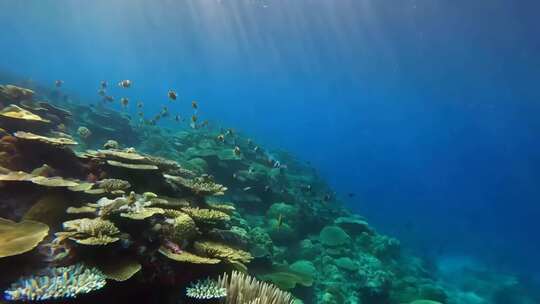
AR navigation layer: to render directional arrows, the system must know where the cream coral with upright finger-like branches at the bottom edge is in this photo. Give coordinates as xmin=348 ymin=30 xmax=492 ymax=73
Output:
xmin=218 ymin=271 xmax=293 ymax=304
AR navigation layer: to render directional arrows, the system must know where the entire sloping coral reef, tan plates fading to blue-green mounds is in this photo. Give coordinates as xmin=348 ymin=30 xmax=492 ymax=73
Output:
xmin=0 ymin=81 xmax=536 ymax=304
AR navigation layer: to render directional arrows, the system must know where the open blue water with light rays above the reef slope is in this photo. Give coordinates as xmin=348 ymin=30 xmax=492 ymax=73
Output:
xmin=0 ymin=0 xmax=540 ymax=286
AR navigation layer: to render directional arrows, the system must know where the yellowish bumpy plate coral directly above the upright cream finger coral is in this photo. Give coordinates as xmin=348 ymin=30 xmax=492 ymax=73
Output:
xmin=193 ymin=241 xmax=253 ymax=264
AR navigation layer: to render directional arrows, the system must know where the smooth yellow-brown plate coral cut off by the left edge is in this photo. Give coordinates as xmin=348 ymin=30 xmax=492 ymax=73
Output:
xmin=0 ymin=218 xmax=49 ymax=258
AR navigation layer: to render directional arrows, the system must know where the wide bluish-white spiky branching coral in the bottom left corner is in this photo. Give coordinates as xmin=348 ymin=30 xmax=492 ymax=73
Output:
xmin=4 ymin=264 xmax=107 ymax=301
